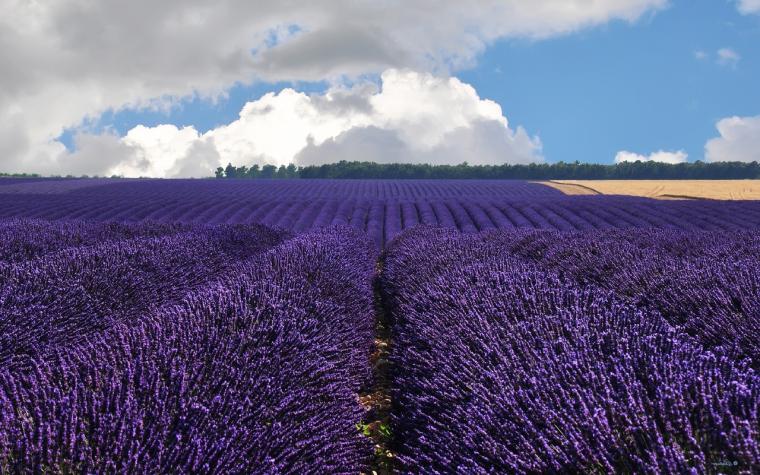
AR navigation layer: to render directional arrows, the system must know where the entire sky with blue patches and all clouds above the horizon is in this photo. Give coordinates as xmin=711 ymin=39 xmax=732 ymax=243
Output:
xmin=0 ymin=0 xmax=760 ymax=177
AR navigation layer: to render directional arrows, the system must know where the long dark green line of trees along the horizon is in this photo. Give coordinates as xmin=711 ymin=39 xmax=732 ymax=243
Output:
xmin=216 ymin=161 xmax=760 ymax=180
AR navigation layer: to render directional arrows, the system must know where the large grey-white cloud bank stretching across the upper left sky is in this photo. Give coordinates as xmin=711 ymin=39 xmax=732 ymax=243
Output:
xmin=0 ymin=0 xmax=668 ymax=173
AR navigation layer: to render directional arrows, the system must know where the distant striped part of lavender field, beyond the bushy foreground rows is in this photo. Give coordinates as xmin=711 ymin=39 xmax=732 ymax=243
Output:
xmin=0 ymin=178 xmax=760 ymax=247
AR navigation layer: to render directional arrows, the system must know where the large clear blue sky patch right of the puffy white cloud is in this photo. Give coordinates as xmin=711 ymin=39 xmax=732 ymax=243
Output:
xmin=459 ymin=0 xmax=760 ymax=163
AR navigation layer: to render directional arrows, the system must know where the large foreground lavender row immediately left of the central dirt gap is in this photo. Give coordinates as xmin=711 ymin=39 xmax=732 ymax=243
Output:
xmin=0 ymin=229 xmax=374 ymax=473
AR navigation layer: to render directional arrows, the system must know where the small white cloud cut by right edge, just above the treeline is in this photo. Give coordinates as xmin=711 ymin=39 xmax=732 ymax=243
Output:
xmin=705 ymin=116 xmax=760 ymax=162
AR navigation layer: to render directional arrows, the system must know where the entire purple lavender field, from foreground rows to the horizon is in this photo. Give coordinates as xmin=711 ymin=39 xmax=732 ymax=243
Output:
xmin=0 ymin=179 xmax=760 ymax=473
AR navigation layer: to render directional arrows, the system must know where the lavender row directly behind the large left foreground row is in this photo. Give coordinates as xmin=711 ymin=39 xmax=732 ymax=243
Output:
xmin=0 ymin=226 xmax=284 ymax=366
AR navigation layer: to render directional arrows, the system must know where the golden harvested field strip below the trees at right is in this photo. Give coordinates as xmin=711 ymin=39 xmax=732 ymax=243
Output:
xmin=541 ymin=180 xmax=760 ymax=200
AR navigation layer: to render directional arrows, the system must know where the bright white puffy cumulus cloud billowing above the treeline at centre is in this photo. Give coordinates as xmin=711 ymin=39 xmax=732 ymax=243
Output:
xmin=96 ymin=70 xmax=543 ymax=177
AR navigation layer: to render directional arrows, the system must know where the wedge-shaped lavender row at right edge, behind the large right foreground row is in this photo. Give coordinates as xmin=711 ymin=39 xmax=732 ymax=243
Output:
xmin=498 ymin=230 xmax=760 ymax=367
